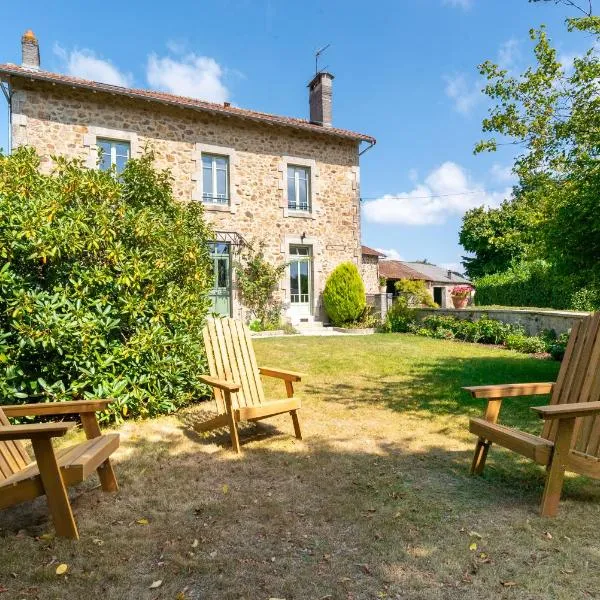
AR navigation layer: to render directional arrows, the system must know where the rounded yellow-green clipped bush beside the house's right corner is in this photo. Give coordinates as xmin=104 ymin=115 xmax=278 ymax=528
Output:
xmin=323 ymin=262 xmax=367 ymax=326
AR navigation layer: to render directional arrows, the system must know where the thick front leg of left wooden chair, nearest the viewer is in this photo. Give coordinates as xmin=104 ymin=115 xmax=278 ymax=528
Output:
xmin=32 ymin=438 xmax=79 ymax=540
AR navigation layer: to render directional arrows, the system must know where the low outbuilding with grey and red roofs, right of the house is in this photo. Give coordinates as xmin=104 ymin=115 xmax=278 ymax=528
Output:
xmin=379 ymin=260 xmax=472 ymax=308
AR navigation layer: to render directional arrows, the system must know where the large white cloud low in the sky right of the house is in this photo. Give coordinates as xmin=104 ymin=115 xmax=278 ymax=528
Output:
xmin=363 ymin=161 xmax=511 ymax=225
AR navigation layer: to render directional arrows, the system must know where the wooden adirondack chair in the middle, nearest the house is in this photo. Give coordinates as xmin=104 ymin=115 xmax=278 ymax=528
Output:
xmin=194 ymin=318 xmax=302 ymax=452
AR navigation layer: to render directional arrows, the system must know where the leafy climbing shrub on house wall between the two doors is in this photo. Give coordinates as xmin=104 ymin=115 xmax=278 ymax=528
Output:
xmin=235 ymin=243 xmax=286 ymax=331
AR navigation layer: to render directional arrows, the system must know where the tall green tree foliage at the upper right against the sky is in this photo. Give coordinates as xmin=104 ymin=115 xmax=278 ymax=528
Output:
xmin=460 ymin=8 xmax=600 ymax=310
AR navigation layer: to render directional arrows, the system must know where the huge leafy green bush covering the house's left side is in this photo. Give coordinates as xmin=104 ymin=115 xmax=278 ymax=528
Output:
xmin=0 ymin=149 xmax=210 ymax=420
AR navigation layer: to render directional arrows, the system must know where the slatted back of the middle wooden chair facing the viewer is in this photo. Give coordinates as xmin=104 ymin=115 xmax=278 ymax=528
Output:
xmin=203 ymin=318 xmax=265 ymax=413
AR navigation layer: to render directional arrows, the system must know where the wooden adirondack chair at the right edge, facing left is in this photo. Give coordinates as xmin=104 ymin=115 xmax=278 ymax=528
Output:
xmin=463 ymin=313 xmax=600 ymax=517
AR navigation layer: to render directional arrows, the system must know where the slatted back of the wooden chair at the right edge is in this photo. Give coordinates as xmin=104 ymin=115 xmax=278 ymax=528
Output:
xmin=542 ymin=313 xmax=600 ymax=458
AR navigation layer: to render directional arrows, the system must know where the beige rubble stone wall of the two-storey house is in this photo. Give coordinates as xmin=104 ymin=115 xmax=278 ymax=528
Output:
xmin=12 ymin=78 xmax=360 ymax=318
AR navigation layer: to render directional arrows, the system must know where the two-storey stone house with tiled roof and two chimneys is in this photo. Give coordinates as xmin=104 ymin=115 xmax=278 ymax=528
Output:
xmin=0 ymin=31 xmax=375 ymax=323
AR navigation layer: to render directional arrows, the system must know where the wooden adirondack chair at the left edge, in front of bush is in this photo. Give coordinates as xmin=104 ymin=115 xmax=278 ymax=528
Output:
xmin=0 ymin=400 xmax=119 ymax=539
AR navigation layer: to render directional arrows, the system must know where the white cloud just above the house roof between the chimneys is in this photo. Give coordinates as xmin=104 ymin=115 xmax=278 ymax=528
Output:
xmin=146 ymin=52 xmax=229 ymax=102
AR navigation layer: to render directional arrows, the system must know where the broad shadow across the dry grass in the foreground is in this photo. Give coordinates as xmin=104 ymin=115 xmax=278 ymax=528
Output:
xmin=0 ymin=425 xmax=599 ymax=600
